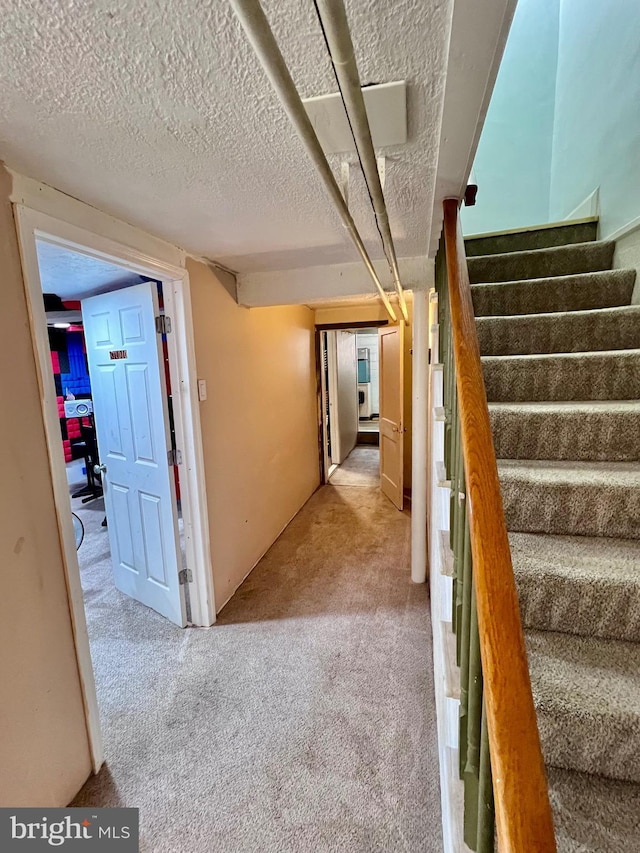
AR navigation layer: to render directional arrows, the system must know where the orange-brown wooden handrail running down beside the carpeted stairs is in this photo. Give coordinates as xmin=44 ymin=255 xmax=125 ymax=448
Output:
xmin=443 ymin=199 xmax=556 ymax=853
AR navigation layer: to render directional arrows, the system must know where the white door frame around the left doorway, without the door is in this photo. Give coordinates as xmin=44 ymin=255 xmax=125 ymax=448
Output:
xmin=14 ymin=204 xmax=216 ymax=773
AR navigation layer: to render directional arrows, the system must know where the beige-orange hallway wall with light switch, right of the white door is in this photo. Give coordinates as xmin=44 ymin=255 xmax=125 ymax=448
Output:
xmin=187 ymin=261 xmax=320 ymax=611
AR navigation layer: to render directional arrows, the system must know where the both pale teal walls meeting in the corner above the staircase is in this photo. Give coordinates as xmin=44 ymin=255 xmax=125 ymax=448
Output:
xmin=462 ymin=0 xmax=640 ymax=237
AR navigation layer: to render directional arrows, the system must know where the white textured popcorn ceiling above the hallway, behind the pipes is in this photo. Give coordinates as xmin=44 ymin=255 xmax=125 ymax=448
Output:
xmin=0 ymin=0 xmax=452 ymax=271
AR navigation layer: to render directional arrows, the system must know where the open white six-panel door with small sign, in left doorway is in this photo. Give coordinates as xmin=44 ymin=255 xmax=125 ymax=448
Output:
xmin=82 ymin=282 xmax=186 ymax=627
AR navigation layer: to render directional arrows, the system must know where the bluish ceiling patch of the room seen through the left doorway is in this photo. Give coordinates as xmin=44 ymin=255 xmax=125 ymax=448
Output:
xmin=36 ymin=240 xmax=141 ymax=299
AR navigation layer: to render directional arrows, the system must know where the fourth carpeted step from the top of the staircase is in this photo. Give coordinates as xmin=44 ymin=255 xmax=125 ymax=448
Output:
xmin=476 ymin=305 xmax=640 ymax=355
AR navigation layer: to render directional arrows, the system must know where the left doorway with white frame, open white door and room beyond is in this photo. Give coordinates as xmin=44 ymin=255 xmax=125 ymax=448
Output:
xmin=16 ymin=205 xmax=215 ymax=772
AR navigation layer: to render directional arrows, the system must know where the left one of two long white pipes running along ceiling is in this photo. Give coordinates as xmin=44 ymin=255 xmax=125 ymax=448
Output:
xmin=230 ymin=0 xmax=406 ymax=322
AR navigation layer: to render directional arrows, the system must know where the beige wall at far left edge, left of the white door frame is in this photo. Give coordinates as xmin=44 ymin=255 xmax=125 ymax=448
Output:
xmin=0 ymin=165 xmax=91 ymax=806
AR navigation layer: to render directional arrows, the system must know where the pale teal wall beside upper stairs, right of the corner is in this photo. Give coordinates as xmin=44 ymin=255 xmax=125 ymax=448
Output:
xmin=550 ymin=0 xmax=640 ymax=236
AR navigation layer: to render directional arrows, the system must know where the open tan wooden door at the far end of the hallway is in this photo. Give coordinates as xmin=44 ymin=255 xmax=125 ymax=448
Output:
xmin=378 ymin=324 xmax=404 ymax=509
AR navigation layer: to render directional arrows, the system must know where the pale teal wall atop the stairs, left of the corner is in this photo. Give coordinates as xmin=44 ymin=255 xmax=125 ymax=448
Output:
xmin=462 ymin=0 xmax=560 ymax=234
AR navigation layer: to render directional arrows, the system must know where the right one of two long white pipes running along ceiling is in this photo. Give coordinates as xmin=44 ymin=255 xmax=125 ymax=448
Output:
xmin=314 ymin=0 xmax=409 ymax=322
